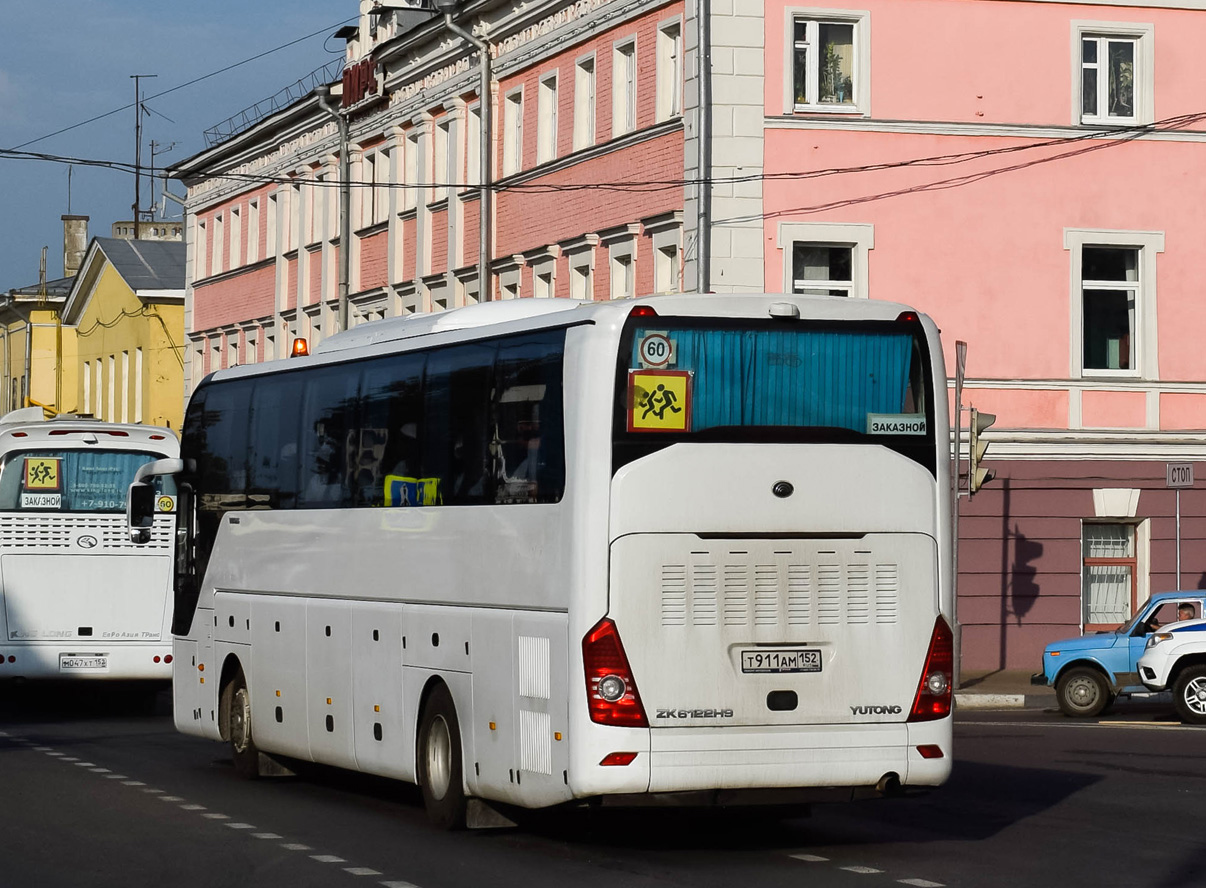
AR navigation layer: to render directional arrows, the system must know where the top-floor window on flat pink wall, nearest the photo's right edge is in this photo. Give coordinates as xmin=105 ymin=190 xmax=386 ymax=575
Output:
xmin=1072 ymin=22 xmax=1155 ymax=125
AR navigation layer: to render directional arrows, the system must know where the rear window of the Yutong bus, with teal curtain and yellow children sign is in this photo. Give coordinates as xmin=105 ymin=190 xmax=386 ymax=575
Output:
xmin=614 ymin=317 xmax=936 ymax=473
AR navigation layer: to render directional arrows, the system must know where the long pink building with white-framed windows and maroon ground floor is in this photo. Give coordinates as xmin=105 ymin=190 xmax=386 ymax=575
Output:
xmin=175 ymin=0 xmax=1206 ymax=671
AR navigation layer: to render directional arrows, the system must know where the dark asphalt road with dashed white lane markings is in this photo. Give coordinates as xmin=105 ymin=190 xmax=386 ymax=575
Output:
xmin=0 ymin=689 xmax=1206 ymax=888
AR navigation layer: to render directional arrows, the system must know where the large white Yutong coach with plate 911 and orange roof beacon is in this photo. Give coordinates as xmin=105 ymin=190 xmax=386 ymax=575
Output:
xmin=131 ymin=296 xmax=952 ymax=825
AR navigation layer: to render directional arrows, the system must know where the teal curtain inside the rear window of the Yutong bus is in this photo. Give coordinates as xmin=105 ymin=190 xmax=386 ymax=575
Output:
xmin=633 ymin=328 xmax=913 ymax=433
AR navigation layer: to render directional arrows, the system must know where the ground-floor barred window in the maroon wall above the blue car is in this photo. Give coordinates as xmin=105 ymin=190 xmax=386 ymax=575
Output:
xmin=1081 ymin=524 xmax=1138 ymax=630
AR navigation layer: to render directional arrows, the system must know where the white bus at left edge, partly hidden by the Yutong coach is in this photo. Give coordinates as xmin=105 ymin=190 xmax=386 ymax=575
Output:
xmin=0 ymin=407 xmax=180 ymax=683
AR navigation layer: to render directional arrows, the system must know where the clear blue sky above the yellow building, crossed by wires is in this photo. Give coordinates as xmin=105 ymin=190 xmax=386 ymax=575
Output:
xmin=0 ymin=0 xmax=359 ymax=291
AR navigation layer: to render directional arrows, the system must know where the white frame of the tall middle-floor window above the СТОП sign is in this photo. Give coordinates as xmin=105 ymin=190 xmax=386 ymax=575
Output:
xmin=1064 ymin=228 xmax=1164 ymax=380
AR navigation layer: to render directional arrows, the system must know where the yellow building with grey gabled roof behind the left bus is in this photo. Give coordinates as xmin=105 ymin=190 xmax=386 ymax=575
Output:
xmin=63 ymin=238 xmax=185 ymax=431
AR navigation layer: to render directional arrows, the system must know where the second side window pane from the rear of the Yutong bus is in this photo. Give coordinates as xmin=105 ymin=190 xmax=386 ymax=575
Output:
xmin=422 ymin=345 xmax=496 ymax=506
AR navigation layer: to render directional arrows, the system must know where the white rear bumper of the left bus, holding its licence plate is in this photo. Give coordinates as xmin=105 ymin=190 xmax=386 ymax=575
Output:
xmin=0 ymin=639 xmax=171 ymax=682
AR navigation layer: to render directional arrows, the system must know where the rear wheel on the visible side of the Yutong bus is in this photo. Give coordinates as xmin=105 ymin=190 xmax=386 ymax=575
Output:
xmin=417 ymin=683 xmax=467 ymax=830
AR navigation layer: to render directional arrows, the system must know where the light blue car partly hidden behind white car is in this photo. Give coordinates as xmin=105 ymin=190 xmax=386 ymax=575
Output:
xmin=1030 ymin=589 xmax=1206 ymax=718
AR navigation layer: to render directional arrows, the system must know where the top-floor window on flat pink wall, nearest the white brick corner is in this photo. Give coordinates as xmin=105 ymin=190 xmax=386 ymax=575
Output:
xmin=786 ymin=10 xmax=871 ymax=113
